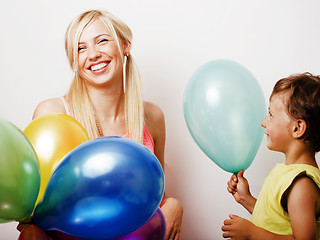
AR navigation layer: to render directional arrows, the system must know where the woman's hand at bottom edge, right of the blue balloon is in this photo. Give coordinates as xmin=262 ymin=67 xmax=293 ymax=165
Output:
xmin=161 ymin=198 xmax=183 ymax=240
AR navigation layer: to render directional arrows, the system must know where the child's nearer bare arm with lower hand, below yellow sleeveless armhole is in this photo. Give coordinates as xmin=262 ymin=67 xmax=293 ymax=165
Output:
xmin=221 ymin=174 xmax=320 ymax=240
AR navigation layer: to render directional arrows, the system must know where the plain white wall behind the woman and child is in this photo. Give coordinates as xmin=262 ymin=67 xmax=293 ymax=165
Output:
xmin=0 ymin=0 xmax=320 ymax=240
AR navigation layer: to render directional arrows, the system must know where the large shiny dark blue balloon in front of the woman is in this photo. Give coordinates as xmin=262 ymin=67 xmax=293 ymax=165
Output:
xmin=33 ymin=137 xmax=164 ymax=240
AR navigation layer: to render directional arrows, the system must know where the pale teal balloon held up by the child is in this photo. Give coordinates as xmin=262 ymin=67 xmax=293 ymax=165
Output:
xmin=183 ymin=60 xmax=266 ymax=173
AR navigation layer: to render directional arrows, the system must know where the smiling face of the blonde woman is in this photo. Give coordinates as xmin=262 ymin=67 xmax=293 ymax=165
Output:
xmin=78 ymin=20 xmax=123 ymax=85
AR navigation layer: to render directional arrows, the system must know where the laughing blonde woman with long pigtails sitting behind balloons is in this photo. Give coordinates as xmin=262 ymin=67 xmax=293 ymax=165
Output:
xmin=33 ymin=10 xmax=183 ymax=240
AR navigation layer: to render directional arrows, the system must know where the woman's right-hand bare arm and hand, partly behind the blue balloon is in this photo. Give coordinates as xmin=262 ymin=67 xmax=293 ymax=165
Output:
xmin=145 ymin=102 xmax=183 ymax=240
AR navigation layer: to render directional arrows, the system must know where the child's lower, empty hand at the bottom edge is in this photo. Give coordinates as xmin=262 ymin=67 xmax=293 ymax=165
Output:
xmin=221 ymin=214 xmax=254 ymax=240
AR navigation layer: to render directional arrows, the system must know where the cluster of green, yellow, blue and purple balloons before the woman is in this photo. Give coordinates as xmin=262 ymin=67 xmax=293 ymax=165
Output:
xmin=0 ymin=114 xmax=166 ymax=240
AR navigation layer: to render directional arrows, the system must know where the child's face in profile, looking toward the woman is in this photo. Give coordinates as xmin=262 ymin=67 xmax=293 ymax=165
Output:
xmin=261 ymin=93 xmax=294 ymax=153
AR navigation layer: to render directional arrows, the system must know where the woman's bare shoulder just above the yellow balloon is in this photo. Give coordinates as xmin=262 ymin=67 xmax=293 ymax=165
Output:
xmin=33 ymin=98 xmax=66 ymax=119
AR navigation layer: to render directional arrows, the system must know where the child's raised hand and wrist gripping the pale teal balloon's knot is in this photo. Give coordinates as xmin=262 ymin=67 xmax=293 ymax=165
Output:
xmin=227 ymin=170 xmax=257 ymax=213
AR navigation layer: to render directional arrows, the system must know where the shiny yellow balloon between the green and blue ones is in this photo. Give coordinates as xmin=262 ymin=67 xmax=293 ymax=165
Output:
xmin=24 ymin=113 xmax=89 ymax=204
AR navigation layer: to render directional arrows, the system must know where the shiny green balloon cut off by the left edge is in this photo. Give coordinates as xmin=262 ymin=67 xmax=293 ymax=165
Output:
xmin=0 ymin=118 xmax=40 ymax=222
